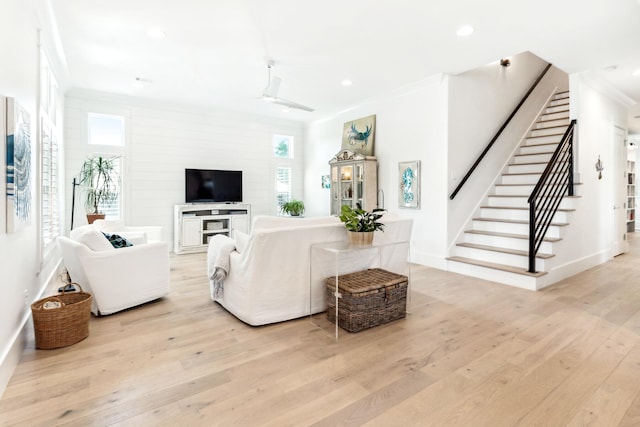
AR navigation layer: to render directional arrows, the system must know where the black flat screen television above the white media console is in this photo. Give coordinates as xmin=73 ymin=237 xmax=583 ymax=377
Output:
xmin=184 ymin=169 xmax=242 ymax=203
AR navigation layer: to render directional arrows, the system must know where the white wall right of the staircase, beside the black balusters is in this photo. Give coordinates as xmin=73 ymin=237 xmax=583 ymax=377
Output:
xmin=550 ymin=74 xmax=627 ymax=280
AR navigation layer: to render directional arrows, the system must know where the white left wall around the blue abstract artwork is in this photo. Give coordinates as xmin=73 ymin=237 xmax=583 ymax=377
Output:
xmin=0 ymin=0 xmax=64 ymax=394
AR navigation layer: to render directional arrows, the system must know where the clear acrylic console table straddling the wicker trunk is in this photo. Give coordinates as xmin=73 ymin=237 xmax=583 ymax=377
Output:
xmin=309 ymin=241 xmax=411 ymax=340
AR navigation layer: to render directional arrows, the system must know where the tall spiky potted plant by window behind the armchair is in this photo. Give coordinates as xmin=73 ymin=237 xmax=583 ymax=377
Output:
xmin=79 ymin=156 xmax=120 ymax=224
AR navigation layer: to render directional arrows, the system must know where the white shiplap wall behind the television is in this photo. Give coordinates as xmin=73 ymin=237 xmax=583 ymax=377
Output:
xmin=65 ymin=90 xmax=305 ymax=242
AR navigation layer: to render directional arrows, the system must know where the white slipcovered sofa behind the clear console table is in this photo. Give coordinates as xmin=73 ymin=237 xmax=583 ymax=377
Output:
xmin=208 ymin=214 xmax=413 ymax=326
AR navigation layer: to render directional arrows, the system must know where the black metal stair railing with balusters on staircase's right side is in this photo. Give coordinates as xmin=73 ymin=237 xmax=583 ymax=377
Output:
xmin=528 ymin=119 xmax=576 ymax=273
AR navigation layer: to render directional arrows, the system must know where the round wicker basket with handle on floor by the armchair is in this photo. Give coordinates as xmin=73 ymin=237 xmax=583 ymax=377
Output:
xmin=31 ymin=283 xmax=93 ymax=350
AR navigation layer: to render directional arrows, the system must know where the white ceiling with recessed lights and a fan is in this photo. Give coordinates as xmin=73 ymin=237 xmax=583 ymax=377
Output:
xmin=51 ymin=0 xmax=640 ymax=132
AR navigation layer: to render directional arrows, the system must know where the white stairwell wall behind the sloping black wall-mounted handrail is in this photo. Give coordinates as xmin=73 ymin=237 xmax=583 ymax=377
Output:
xmin=448 ymin=52 xmax=569 ymax=245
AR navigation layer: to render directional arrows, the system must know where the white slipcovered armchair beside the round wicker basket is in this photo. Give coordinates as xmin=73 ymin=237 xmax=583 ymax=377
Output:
xmin=57 ymin=226 xmax=170 ymax=315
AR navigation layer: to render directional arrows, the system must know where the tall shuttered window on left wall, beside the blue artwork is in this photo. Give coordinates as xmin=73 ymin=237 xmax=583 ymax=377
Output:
xmin=39 ymin=52 xmax=61 ymax=258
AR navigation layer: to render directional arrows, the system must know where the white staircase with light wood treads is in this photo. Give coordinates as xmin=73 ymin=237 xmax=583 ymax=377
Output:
xmin=447 ymin=92 xmax=574 ymax=290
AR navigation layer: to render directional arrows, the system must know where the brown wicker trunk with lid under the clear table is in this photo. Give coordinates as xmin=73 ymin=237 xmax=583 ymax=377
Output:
xmin=325 ymin=268 xmax=409 ymax=332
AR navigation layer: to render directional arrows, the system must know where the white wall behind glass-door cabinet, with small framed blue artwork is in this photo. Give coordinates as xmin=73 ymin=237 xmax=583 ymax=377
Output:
xmin=305 ymin=75 xmax=448 ymax=266
